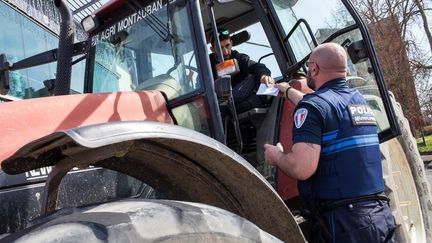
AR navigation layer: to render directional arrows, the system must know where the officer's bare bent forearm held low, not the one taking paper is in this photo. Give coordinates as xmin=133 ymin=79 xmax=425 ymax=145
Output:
xmin=264 ymin=142 xmax=321 ymax=180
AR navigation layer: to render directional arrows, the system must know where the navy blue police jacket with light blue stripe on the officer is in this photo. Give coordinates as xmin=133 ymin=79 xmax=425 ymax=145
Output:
xmin=293 ymin=79 xmax=384 ymax=200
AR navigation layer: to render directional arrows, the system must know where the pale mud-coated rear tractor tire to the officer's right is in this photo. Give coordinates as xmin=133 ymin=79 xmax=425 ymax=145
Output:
xmin=381 ymin=92 xmax=432 ymax=243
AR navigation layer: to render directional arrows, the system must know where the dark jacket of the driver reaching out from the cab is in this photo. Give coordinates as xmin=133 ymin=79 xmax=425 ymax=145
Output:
xmin=210 ymin=50 xmax=271 ymax=87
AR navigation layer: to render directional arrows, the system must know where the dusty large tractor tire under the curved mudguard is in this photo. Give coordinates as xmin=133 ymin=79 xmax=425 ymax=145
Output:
xmin=3 ymin=200 xmax=281 ymax=243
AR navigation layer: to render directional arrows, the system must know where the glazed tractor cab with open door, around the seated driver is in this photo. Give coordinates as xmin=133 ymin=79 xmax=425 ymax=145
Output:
xmin=82 ymin=0 xmax=398 ymax=191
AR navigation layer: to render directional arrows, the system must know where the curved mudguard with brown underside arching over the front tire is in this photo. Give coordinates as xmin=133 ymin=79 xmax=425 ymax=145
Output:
xmin=2 ymin=122 xmax=304 ymax=242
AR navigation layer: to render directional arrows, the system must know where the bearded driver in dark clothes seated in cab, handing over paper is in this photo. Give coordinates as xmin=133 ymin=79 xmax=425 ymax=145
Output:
xmin=210 ymin=29 xmax=275 ymax=117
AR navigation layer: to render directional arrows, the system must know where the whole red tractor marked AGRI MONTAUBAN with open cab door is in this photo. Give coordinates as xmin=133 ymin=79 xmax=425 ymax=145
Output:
xmin=0 ymin=0 xmax=432 ymax=242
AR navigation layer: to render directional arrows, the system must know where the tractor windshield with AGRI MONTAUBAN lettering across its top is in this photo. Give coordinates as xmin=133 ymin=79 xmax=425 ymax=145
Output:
xmin=89 ymin=0 xmax=200 ymax=99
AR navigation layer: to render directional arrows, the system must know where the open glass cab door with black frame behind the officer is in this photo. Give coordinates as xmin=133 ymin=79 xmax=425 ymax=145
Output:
xmin=257 ymin=0 xmax=400 ymax=143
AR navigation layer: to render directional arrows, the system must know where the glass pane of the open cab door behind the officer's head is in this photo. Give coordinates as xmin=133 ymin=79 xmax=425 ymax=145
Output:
xmin=271 ymin=0 xmax=390 ymax=137
